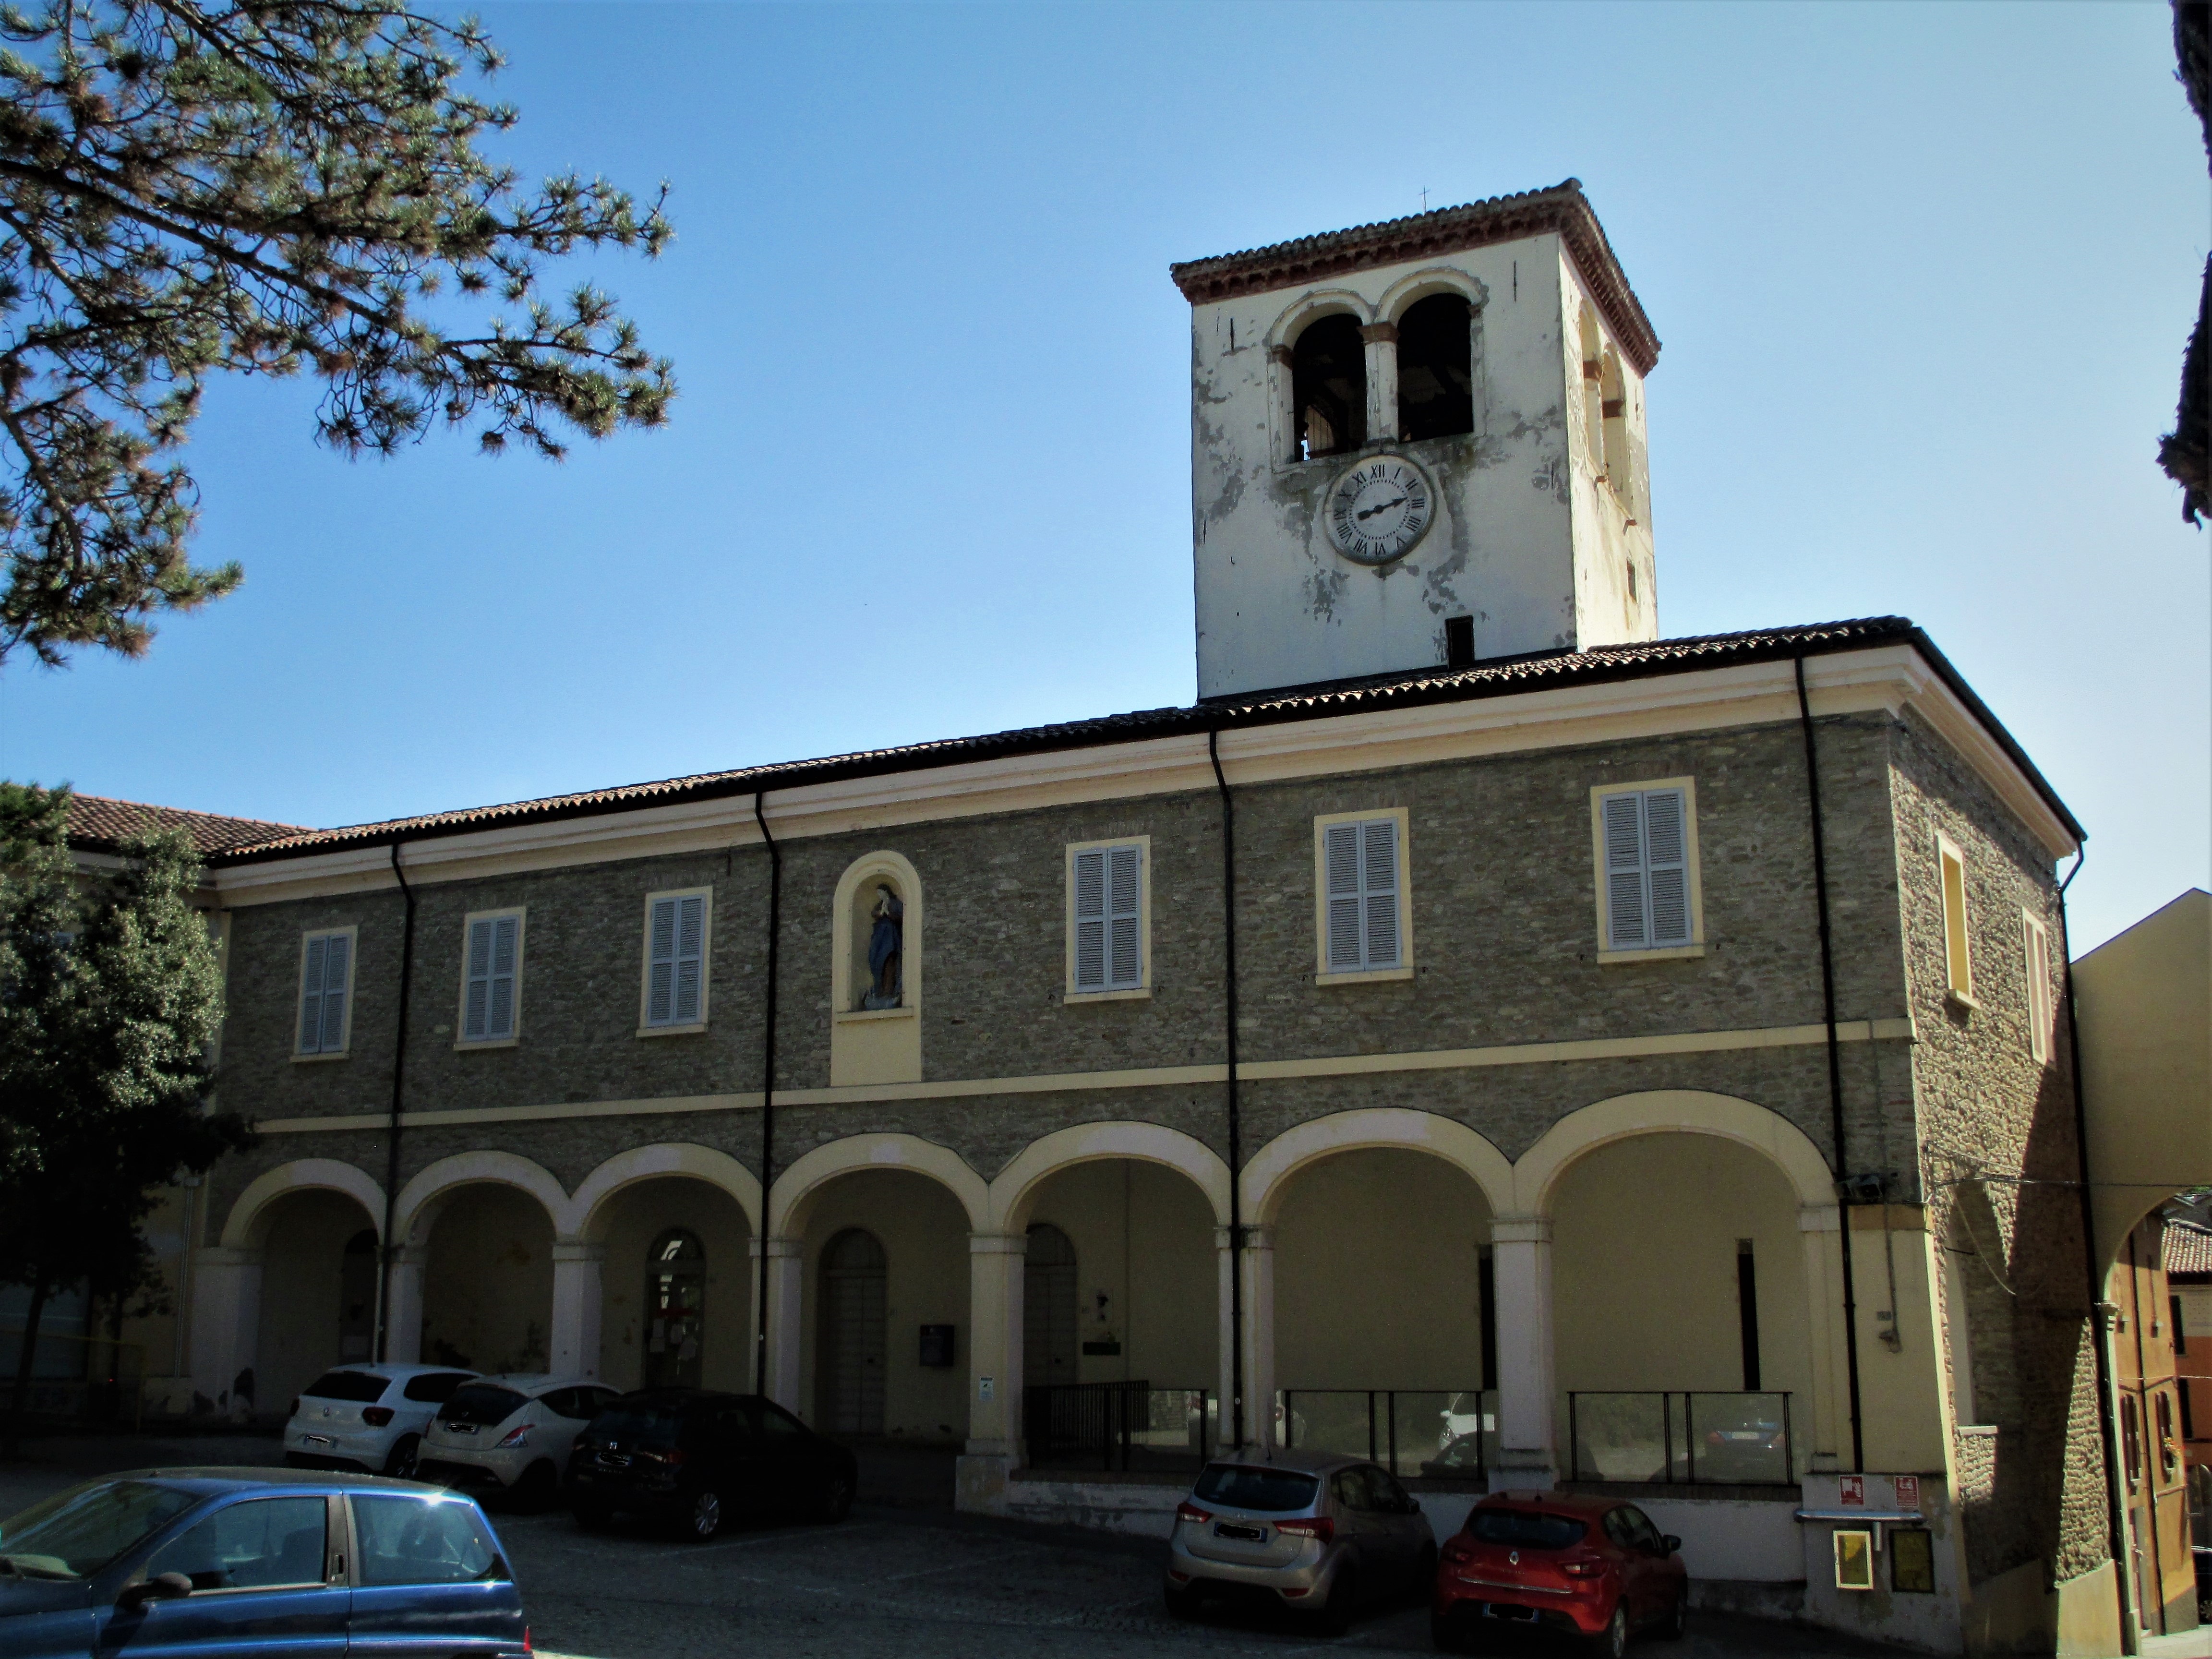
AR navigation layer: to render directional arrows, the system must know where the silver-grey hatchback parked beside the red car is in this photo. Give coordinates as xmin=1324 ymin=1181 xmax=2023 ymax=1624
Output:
xmin=1164 ymin=1451 xmax=1436 ymax=1630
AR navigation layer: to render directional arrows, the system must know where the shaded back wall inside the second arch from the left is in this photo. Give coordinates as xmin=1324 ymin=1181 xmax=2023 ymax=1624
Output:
xmin=422 ymin=1183 xmax=553 ymax=1371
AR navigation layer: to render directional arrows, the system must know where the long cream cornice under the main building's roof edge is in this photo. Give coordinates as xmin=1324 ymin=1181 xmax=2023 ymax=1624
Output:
xmin=215 ymin=644 xmax=2075 ymax=905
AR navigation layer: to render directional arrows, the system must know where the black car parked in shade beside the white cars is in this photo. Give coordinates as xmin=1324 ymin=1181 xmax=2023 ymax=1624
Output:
xmin=562 ymin=1389 xmax=858 ymax=1538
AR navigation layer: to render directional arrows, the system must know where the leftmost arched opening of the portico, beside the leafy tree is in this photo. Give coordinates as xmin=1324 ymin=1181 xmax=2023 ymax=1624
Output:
xmin=254 ymin=1188 xmax=376 ymax=1411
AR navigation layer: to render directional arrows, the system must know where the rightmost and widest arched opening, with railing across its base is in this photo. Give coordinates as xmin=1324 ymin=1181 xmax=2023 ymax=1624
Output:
xmin=1551 ymin=1130 xmax=1814 ymax=1482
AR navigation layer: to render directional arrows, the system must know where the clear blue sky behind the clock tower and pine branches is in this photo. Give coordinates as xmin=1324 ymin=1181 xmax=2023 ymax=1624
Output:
xmin=0 ymin=0 xmax=2212 ymax=949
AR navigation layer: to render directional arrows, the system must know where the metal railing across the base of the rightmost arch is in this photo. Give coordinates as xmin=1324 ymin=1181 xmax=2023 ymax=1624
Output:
xmin=1566 ymin=1389 xmax=1796 ymax=1484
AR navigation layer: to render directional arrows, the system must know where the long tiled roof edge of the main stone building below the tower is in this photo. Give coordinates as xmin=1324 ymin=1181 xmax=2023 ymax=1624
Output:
xmin=199 ymin=617 xmax=2084 ymax=865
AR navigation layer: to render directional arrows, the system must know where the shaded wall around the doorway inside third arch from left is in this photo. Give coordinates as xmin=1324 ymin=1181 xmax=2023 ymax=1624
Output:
xmin=600 ymin=1177 xmax=754 ymax=1394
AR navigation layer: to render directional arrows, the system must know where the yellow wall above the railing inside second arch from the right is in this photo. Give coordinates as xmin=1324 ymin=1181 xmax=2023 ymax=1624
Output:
xmin=1274 ymin=1148 xmax=1491 ymax=1389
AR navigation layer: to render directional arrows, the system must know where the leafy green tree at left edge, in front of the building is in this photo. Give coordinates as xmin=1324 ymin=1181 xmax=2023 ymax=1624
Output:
xmin=0 ymin=783 xmax=252 ymax=1447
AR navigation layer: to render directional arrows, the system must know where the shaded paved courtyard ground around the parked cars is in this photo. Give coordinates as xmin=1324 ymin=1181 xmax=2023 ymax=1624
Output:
xmin=0 ymin=1436 xmax=1902 ymax=1659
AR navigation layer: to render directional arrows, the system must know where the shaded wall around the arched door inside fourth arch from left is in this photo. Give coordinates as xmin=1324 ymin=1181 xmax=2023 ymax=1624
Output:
xmin=798 ymin=1170 xmax=974 ymax=1442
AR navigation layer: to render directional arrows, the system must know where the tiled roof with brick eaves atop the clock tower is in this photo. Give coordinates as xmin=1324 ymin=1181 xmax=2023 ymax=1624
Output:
xmin=1168 ymin=179 xmax=1659 ymax=374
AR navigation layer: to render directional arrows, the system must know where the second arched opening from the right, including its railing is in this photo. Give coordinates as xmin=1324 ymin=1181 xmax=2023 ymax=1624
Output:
xmin=1274 ymin=1146 xmax=1495 ymax=1476
